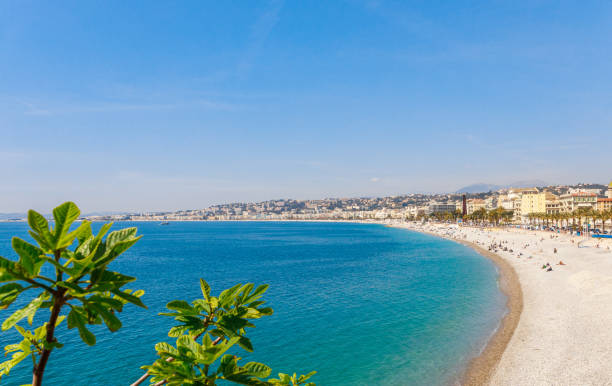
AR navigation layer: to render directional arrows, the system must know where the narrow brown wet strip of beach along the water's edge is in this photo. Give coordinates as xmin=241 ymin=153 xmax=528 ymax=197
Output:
xmin=390 ymin=223 xmax=523 ymax=386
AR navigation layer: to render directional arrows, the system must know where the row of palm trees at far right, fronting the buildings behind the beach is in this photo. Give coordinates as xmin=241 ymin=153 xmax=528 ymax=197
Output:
xmin=527 ymin=208 xmax=612 ymax=231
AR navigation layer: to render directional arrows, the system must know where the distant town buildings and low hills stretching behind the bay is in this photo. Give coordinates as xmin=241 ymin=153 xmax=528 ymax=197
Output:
xmin=88 ymin=182 xmax=612 ymax=223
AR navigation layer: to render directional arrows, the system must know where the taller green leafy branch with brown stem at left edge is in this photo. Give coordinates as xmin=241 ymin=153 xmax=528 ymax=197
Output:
xmin=0 ymin=202 xmax=145 ymax=386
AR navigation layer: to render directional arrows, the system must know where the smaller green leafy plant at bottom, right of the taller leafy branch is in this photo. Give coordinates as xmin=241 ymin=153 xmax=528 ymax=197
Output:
xmin=143 ymin=279 xmax=315 ymax=386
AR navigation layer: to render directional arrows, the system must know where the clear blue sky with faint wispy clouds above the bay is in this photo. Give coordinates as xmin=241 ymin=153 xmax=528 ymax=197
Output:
xmin=0 ymin=0 xmax=612 ymax=212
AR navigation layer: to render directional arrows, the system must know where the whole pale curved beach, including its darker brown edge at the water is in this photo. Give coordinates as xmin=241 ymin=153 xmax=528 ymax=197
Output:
xmin=389 ymin=223 xmax=612 ymax=386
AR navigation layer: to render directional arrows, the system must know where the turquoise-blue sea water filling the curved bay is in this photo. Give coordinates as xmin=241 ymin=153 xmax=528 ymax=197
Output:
xmin=0 ymin=222 xmax=505 ymax=385
